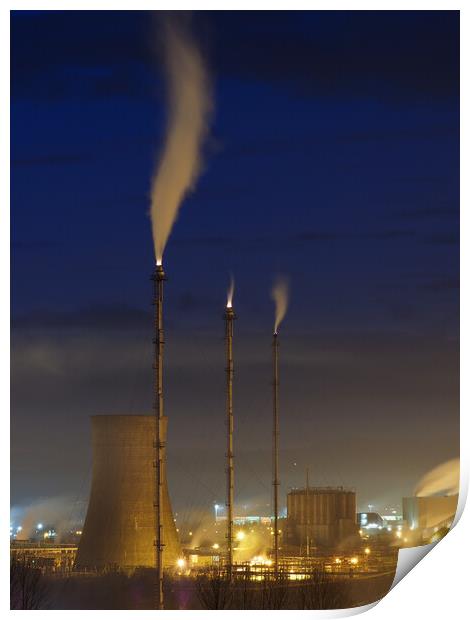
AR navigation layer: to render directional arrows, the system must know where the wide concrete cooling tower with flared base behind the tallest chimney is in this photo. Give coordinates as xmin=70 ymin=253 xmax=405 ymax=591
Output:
xmin=75 ymin=415 xmax=181 ymax=570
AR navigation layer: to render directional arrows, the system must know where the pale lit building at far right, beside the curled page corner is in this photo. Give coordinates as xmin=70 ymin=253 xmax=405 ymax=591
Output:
xmin=403 ymin=495 xmax=459 ymax=530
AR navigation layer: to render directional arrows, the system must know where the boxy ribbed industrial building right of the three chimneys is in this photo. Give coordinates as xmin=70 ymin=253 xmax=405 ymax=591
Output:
xmin=286 ymin=487 xmax=358 ymax=548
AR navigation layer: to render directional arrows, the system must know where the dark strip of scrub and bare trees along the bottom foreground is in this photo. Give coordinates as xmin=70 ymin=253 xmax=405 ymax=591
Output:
xmin=28 ymin=569 xmax=393 ymax=609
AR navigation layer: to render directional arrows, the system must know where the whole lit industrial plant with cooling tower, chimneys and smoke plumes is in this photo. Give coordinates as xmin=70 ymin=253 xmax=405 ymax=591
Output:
xmin=10 ymin=14 xmax=458 ymax=610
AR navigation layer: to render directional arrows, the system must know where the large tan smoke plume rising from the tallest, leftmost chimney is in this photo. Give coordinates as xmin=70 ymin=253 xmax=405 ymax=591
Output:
xmin=150 ymin=23 xmax=212 ymax=263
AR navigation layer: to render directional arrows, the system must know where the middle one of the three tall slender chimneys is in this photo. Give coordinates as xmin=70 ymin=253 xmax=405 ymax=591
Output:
xmin=225 ymin=300 xmax=235 ymax=579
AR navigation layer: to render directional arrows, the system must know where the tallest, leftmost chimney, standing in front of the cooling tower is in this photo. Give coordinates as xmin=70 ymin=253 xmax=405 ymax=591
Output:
xmin=153 ymin=264 xmax=166 ymax=609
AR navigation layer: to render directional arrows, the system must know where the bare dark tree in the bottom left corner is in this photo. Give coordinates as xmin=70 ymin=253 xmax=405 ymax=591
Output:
xmin=10 ymin=556 xmax=47 ymax=609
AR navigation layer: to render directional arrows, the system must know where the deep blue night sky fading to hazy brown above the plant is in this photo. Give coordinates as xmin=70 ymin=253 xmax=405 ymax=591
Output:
xmin=11 ymin=11 xmax=459 ymax=519
